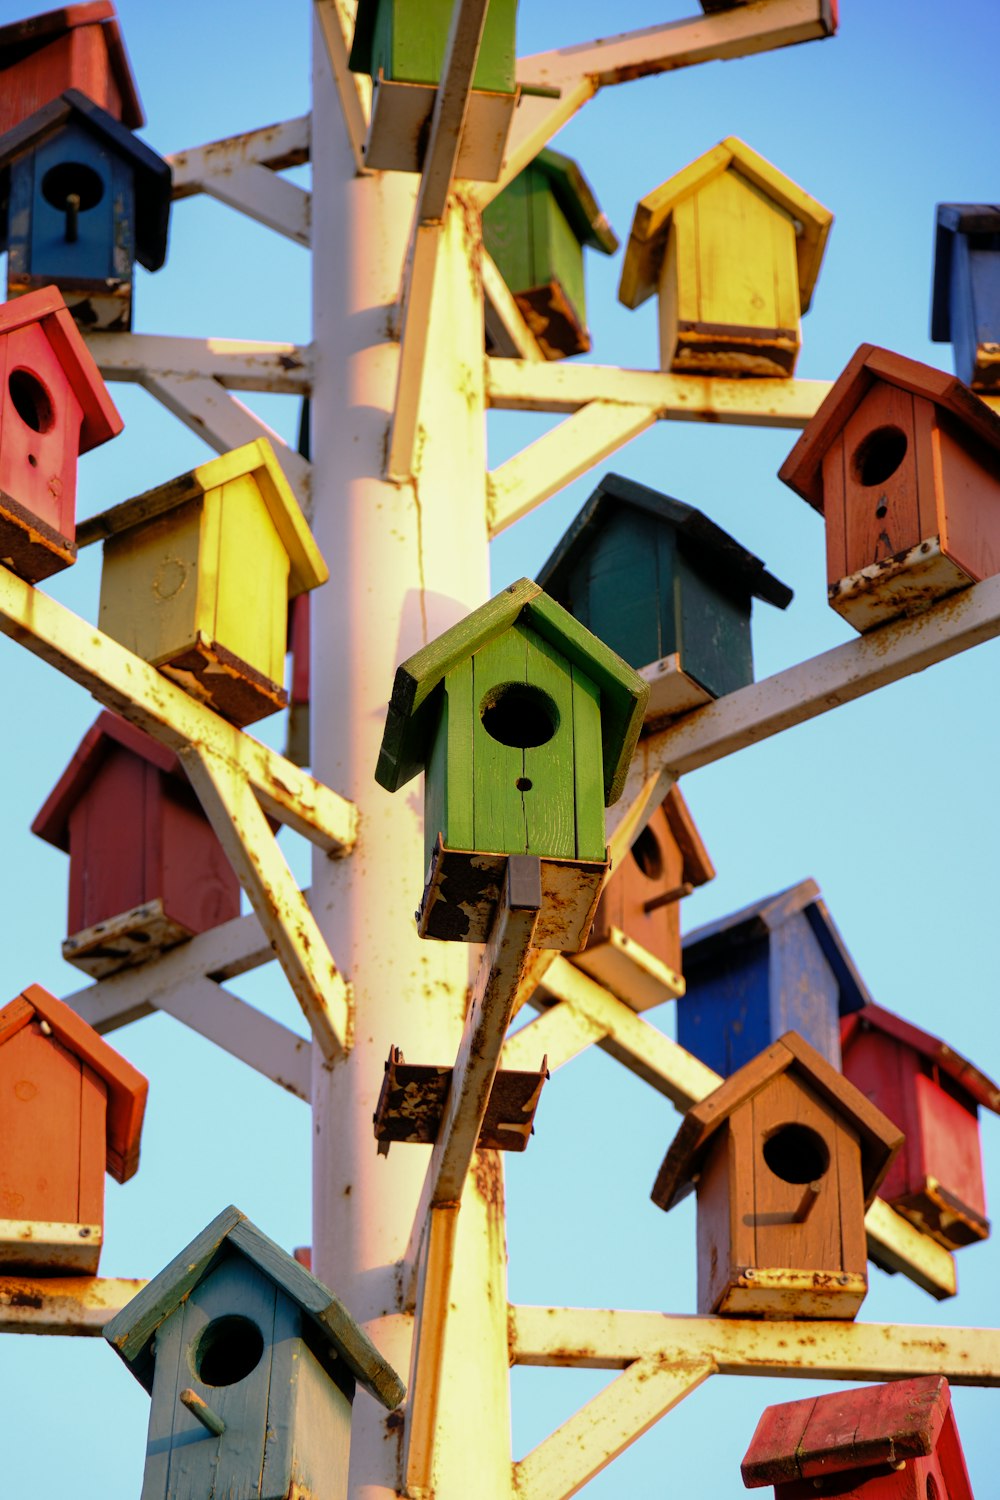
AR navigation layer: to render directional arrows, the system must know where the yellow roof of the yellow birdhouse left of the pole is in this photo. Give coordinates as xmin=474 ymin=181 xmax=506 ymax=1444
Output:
xmin=76 ymin=438 xmax=330 ymax=599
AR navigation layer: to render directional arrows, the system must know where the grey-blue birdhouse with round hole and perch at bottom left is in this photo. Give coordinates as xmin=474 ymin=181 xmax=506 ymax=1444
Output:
xmin=103 ymin=1208 xmax=405 ymax=1500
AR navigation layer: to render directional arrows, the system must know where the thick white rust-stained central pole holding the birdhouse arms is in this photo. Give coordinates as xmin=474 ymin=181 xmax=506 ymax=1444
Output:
xmin=312 ymin=14 xmax=511 ymax=1500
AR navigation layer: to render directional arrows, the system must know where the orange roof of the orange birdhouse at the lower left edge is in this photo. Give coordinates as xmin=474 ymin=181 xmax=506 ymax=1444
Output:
xmin=0 ymin=984 xmax=150 ymax=1182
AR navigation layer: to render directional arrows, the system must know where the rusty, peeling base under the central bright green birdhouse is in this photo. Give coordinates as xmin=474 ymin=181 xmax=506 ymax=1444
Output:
xmin=417 ymin=840 xmax=609 ymax=953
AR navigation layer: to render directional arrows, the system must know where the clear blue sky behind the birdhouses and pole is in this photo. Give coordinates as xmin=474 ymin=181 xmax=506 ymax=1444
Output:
xmin=0 ymin=0 xmax=1000 ymax=1500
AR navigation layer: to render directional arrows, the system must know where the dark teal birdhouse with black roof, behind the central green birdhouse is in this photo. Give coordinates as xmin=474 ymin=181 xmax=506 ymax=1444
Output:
xmin=538 ymin=474 xmax=792 ymax=722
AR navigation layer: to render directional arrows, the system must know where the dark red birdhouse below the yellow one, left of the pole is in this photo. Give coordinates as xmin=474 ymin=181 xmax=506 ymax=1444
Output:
xmin=31 ymin=713 xmax=240 ymax=980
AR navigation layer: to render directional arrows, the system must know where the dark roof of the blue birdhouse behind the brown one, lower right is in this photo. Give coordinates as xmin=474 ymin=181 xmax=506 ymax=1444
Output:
xmin=684 ymin=881 xmax=871 ymax=1016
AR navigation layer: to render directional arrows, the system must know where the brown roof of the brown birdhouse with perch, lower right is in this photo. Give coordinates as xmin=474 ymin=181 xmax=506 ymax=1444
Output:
xmin=651 ymin=1032 xmax=903 ymax=1211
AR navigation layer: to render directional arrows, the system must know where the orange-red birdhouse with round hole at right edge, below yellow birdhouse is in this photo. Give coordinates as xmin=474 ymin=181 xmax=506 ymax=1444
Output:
xmin=778 ymin=344 xmax=1000 ymax=633
